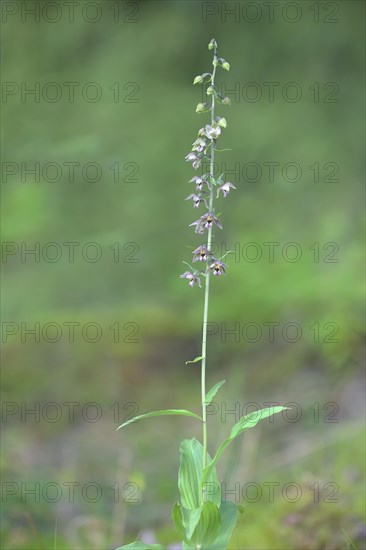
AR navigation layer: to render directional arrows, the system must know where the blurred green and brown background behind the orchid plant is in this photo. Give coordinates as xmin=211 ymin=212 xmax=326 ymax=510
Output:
xmin=1 ymin=0 xmax=365 ymax=550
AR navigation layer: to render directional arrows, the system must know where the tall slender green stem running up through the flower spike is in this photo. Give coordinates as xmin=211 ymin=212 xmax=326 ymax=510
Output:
xmin=201 ymin=47 xmax=216 ymax=501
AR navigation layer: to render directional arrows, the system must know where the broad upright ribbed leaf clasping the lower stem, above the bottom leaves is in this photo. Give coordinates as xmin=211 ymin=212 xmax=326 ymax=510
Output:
xmin=178 ymin=438 xmax=221 ymax=510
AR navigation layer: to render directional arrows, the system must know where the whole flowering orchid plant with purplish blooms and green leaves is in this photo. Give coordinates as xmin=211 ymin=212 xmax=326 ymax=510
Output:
xmin=118 ymin=39 xmax=286 ymax=550
